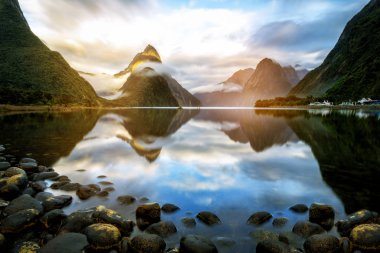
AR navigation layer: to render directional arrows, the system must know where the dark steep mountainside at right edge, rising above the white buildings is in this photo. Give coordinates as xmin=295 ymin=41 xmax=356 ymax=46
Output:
xmin=289 ymin=0 xmax=380 ymax=101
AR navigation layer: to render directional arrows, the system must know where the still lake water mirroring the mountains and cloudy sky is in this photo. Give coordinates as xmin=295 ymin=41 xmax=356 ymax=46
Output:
xmin=0 ymin=109 xmax=380 ymax=252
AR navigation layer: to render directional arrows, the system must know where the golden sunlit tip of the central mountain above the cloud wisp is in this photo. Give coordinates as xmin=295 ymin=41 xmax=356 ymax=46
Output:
xmin=114 ymin=44 xmax=162 ymax=77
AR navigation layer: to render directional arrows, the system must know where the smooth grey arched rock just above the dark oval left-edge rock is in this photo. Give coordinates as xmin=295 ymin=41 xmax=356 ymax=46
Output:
xmin=3 ymin=194 xmax=44 ymax=215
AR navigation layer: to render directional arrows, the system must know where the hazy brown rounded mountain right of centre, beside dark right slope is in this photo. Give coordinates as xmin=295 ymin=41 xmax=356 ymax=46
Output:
xmin=243 ymin=58 xmax=299 ymax=103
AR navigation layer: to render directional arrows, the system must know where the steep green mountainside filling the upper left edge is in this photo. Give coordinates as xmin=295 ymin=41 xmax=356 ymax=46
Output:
xmin=0 ymin=0 xmax=101 ymax=106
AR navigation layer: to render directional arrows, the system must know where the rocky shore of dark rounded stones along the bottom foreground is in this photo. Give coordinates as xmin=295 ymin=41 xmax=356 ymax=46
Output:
xmin=0 ymin=145 xmax=380 ymax=253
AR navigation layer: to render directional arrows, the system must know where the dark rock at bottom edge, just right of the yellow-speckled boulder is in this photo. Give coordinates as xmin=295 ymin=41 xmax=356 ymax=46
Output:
xmin=129 ymin=234 xmax=166 ymax=253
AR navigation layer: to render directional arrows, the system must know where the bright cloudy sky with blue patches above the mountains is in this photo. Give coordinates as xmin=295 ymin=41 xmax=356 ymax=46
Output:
xmin=19 ymin=0 xmax=369 ymax=93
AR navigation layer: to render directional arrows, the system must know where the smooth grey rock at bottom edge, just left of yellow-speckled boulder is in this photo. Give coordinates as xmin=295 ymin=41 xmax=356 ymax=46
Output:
xmin=40 ymin=233 xmax=88 ymax=253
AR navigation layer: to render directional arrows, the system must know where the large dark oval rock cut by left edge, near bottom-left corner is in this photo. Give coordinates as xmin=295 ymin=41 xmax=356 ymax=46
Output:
xmin=0 ymin=209 xmax=40 ymax=234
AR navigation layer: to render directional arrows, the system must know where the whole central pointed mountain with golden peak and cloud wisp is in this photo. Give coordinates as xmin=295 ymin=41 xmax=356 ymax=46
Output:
xmin=115 ymin=45 xmax=200 ymax=107
